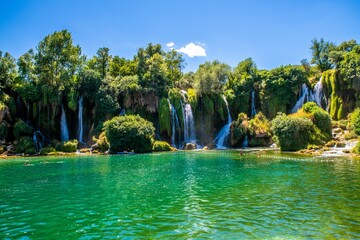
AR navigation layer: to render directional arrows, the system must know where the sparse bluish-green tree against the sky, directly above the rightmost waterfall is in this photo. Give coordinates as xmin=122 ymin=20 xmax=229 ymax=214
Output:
xmin=310 ymin=38 xmax=335 ymax=72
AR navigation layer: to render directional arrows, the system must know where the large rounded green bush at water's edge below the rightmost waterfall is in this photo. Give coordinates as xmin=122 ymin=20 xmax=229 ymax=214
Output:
xmin=271 ymin=113 xmax=314 ymax=151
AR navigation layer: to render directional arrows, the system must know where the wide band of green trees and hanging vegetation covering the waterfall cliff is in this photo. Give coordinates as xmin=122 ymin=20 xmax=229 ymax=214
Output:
xmin=0 ymin=30 xmax=360 ymax=152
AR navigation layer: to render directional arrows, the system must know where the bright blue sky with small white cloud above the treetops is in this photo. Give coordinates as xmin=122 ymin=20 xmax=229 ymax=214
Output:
xmin=0 ymin=0 xmax=360 ymax=71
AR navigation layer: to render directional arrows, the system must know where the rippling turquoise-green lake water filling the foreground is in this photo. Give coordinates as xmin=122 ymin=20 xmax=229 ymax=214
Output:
xmin=0 ymin=151 xmax=360 ymax=239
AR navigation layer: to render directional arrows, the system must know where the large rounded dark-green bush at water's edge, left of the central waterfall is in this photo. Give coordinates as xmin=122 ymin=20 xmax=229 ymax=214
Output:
xmin=104 ymin=115 xmax=155 ymax=153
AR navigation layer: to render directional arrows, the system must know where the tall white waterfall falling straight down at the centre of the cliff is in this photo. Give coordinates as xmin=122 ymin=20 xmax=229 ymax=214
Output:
xmin=181 ymin=90 xmax=196 ymax=143
